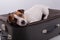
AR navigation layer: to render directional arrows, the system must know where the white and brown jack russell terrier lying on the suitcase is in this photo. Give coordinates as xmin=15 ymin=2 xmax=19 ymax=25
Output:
xmin=8 ymin=5 xmax=49 ymax=26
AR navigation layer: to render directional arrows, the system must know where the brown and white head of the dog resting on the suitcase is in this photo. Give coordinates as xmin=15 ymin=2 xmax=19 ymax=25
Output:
xmin=8 ymin=9 xmax=27 ymax=26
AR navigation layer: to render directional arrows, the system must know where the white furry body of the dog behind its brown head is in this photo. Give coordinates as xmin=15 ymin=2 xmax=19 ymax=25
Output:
xmin=24 ymin=5 xmax=49 ymax=23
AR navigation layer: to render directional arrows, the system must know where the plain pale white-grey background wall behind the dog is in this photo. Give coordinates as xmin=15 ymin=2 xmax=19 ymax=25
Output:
xmin=0 ymin=0 xmax=60 ymax=15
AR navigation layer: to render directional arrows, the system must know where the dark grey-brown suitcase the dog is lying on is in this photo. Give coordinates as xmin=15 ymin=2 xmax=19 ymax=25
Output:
xmin=0 ymin=9 xmax=60 ymax=40
